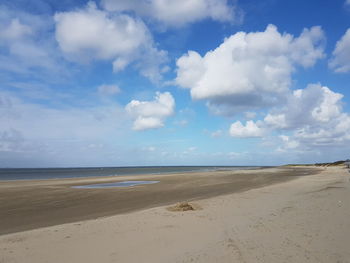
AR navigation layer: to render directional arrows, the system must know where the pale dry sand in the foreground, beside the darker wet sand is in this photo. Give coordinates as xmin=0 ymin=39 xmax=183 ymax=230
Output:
xmin=0 ymin=167 xmax=350 ymax=263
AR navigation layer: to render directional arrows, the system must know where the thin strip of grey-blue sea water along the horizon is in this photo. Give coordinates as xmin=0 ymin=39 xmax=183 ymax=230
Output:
xmin=0 ymin=166 xmax=261 ymax=180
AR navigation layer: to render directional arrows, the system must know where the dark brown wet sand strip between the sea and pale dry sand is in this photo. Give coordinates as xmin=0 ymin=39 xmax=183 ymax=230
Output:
xmin=0 ymin=167 xmax=319 ymax=235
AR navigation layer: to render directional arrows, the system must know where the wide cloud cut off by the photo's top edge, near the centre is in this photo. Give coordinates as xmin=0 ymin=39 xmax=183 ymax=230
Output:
xmin=102 ymin=0 xmax=242 ymax=27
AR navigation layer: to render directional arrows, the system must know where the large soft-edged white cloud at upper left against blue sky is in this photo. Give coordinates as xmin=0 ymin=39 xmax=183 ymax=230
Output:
xmin=54 ymin=2 xmax=167 ymax=81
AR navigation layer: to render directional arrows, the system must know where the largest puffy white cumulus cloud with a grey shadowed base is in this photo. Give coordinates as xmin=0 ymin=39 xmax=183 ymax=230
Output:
xmin=175 ymin=25 xmax=324 ymax=114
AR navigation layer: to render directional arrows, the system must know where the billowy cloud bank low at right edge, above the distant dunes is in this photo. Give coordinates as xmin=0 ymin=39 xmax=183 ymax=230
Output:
xmin=263 ymin=84 xmax=350 ymax=150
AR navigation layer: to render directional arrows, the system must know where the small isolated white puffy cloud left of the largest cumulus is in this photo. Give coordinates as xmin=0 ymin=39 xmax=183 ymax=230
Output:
xmin=125 ymin=92 xmax=175 ymax=131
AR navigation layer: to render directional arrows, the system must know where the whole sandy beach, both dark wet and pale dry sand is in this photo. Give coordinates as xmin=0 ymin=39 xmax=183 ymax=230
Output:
xmin=0 ymin=167 xmax=350 ymax=263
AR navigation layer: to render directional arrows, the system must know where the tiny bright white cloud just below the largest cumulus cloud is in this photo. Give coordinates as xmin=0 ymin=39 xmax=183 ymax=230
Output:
xmin=230 ymin=121 xmax=264 ymax=138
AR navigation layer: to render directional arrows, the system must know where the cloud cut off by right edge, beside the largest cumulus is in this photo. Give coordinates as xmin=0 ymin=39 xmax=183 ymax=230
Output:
xmin=329 ymin=28 xmax=350 ymax=73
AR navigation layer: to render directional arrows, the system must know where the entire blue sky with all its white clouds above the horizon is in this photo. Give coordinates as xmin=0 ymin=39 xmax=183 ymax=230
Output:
xmin=0 ymin=0 xmax=350 ymax=167
